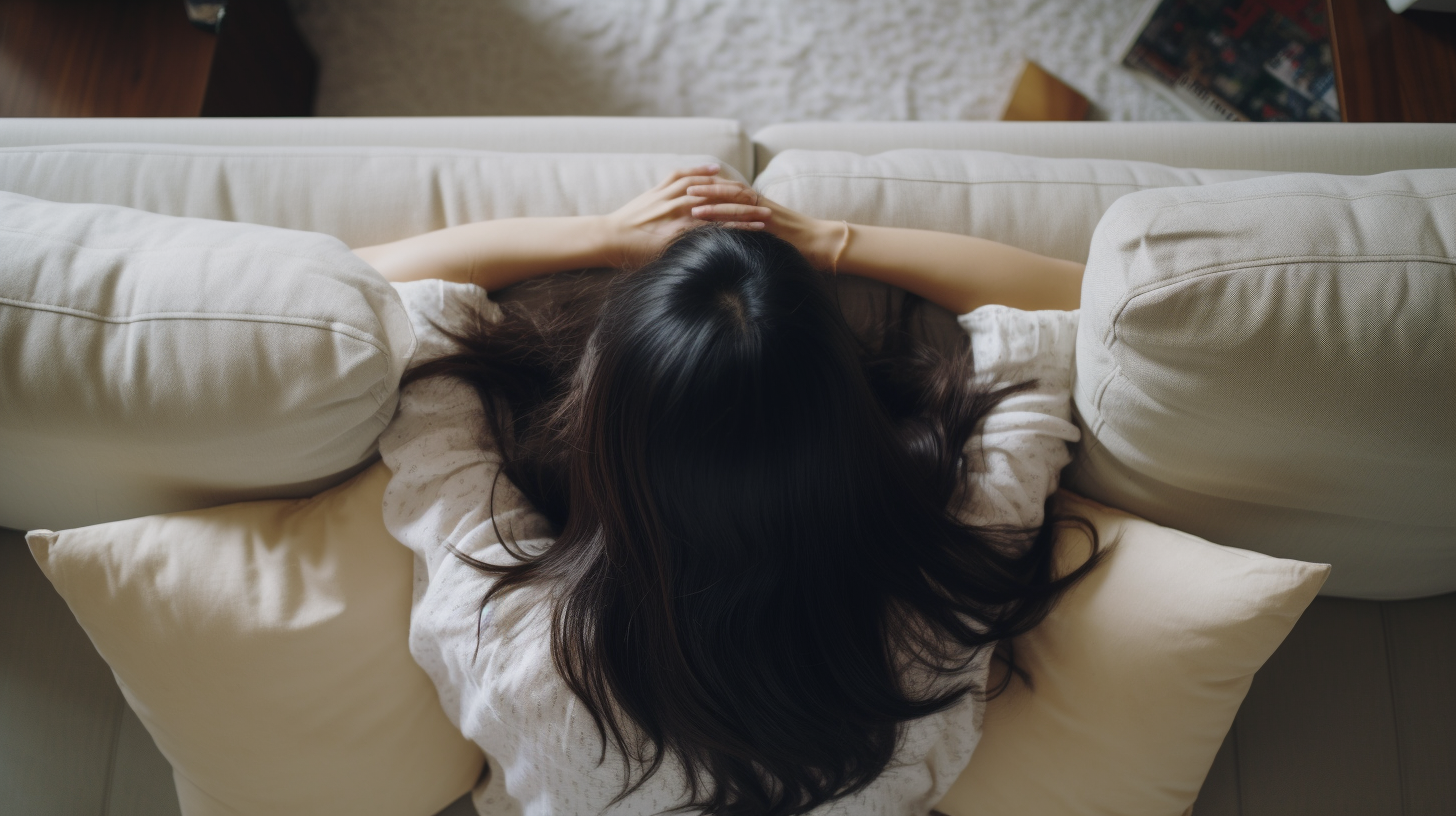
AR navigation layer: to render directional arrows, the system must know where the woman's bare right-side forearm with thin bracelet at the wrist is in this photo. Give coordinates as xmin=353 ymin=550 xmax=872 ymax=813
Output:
xmin=687 ymin=185 xmax=1083 ymax=315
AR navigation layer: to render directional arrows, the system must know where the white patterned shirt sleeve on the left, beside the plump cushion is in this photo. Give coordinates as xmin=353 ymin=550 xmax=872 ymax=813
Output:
xmin=379 ymin=280 xmax=549 ymax=580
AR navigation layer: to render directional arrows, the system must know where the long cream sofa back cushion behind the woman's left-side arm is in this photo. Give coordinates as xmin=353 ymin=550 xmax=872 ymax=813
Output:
xmin=0 ymin=144 xmax=743 ymax=246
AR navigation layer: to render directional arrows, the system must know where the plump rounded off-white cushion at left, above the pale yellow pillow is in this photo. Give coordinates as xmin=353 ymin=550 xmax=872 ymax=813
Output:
xmin=0 ymin=192 xmax=415 ymax=529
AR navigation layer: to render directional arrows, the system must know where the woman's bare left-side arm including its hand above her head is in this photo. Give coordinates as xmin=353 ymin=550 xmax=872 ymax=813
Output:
xmin=354 ymin=165 xmax=763 ymax=291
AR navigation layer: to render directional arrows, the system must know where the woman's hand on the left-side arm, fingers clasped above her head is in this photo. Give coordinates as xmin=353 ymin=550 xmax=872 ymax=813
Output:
xmin=606 ymin=165 xmax=770 ymax=267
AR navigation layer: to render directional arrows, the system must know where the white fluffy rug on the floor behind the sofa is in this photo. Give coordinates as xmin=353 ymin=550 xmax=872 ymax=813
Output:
xmin=293 ymin=0 xmax=1184 ymax=133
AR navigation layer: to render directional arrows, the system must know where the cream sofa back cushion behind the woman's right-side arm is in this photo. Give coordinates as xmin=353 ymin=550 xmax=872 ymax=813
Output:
xmin=754 ymin=150 xmax=1267 ymax=261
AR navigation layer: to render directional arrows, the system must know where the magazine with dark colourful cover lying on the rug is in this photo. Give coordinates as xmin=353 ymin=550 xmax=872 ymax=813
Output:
xmin=1123 ymin=0 xmax=1340 ymax=122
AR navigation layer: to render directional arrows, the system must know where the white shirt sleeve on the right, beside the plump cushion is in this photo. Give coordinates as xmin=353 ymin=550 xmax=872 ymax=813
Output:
xmin=960 ymin=306 xmax=1082 ymax=527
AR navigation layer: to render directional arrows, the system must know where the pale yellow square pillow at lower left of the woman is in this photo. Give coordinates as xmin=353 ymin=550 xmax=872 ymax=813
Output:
xmin=26 ymin=465 xmax=483 ymax=816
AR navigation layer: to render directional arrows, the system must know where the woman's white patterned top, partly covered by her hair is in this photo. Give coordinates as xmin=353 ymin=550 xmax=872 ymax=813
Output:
xmin=380 ymin=281 xmax=1077 ymax=816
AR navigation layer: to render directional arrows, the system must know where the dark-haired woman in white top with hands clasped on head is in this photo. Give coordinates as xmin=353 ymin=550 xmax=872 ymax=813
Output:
xmin=358 ymin=166 xmax=1086 ymax=815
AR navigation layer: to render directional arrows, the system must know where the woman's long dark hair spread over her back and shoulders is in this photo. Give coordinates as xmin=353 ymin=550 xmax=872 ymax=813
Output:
xmin=408 ymin=227 xmax=1091 ymax=815
